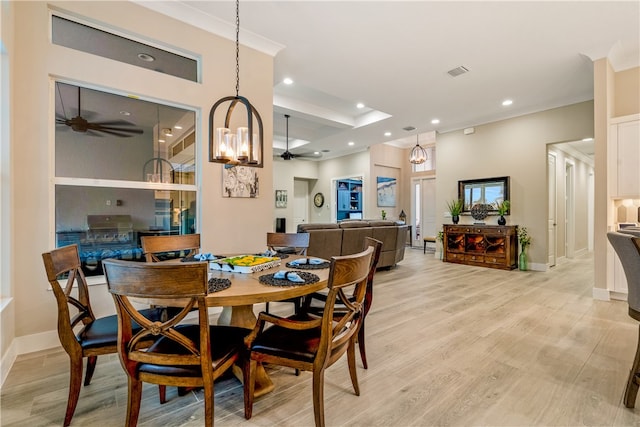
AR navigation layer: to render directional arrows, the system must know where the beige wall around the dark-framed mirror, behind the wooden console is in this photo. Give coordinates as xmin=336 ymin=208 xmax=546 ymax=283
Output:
xmin=436 ymin=102 xmax=593 ymax=267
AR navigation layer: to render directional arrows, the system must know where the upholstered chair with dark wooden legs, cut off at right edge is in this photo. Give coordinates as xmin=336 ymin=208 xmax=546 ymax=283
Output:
xmin=607 ymin=231 xmax=640 ymax=408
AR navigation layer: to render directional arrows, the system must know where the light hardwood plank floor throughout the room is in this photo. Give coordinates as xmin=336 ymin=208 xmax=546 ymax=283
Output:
xmin=0 ymin=248 xmax=640 ymax=427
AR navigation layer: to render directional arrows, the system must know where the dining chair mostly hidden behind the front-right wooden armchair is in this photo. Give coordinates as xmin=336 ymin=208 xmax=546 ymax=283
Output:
xmin=302 ymin=237 xmax=382 ymax=369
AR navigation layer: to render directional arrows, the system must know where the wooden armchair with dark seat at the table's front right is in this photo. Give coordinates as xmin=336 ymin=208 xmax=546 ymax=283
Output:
xmin=244 ymin=247 xmax=374 ymax=427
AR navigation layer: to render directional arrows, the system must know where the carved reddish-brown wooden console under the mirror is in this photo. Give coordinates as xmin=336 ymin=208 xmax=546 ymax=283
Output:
xmin=443 ymin=224 xmax=518 ymax=270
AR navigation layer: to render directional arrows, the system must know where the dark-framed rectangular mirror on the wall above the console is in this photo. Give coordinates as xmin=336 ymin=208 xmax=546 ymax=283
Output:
xmin=458 ymin=176 xmax=510 ymax=215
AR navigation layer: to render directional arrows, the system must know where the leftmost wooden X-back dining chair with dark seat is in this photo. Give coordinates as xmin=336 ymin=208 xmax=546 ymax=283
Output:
xmin=42 ymin=244 xmax=162 ymax=427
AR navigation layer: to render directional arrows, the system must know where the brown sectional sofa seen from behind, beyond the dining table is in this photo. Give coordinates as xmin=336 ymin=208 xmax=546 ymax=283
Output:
xmin=298 ymin=220 xmax=407 ymax=268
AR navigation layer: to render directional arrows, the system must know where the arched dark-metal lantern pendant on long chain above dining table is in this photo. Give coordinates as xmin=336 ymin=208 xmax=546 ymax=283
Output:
xmin=209 ymin=0 xmax=264 ymax=168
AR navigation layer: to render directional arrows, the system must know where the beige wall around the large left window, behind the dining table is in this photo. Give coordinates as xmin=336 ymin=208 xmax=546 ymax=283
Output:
xmin=3 ymin=2 xmax=273 ymax=348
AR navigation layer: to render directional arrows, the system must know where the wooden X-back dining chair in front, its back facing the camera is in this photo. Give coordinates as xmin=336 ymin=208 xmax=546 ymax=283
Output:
xmin=103 ymin=259 xmax=250 ymax=427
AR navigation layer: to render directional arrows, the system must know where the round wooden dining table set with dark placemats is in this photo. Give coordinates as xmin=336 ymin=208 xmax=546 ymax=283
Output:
xmin=140 ymin=254 xmax=330 ymax=397
